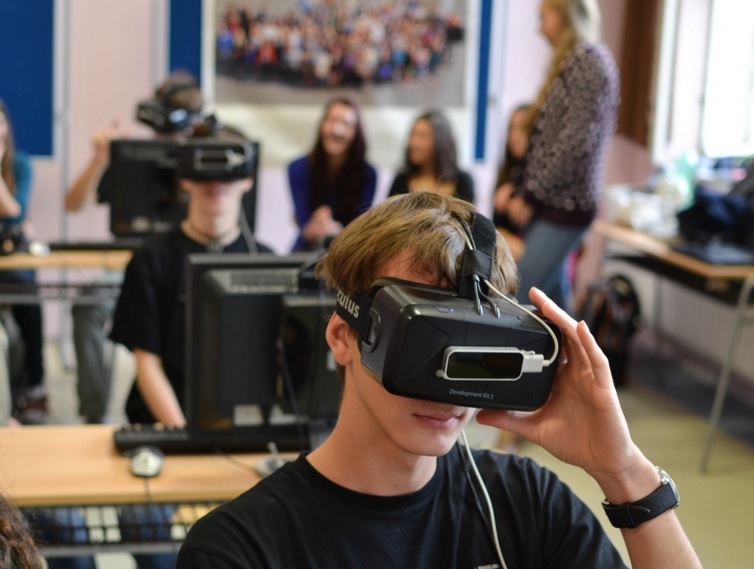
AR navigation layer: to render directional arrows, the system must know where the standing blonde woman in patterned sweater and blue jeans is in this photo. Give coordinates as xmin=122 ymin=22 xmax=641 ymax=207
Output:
xmin=506 ymin=0 xmax=619 ymax=306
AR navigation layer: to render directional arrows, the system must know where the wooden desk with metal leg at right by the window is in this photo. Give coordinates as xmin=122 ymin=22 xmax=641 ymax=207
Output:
xmin=592 ymin=219 xmax=754 ymax=472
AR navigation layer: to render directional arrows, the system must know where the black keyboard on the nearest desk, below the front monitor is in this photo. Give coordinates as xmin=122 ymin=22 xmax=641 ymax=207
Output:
xmin=113 ymin=424 xmax=313 ymax=454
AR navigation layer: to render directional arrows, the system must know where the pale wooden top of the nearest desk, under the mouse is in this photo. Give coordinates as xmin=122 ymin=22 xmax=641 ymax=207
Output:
xmin=0 ymin=425 xmax=265 ymax=556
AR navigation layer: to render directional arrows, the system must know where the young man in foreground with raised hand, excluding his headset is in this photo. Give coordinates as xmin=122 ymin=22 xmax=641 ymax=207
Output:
xmin=177 ymin=192 xmax=700 ymax=569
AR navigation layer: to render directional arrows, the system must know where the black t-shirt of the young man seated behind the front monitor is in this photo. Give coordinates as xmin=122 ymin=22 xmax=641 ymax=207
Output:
xmin=110 ymin=229 xmax=271 ymax=423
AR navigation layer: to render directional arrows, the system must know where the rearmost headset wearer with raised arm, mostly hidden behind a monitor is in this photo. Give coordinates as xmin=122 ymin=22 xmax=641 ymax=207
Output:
xmin=65 ymin=71 xmax=204 ymax=423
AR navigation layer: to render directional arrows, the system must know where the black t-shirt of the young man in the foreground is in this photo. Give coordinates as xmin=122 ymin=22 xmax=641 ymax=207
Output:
xmin=176 ymin=446 xmax=625 ymax=569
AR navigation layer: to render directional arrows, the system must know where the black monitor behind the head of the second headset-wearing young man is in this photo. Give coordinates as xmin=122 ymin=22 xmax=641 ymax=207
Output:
xmin=103 ymin=138 xmax=259 ymax=238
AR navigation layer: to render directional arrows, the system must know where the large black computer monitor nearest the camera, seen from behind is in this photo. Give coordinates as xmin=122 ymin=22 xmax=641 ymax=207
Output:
xmin=185 ymin=253 xmax=340 ymax=451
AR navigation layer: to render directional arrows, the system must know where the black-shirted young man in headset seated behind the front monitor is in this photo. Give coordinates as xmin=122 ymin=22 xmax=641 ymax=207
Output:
xmin=110 ymin=128 xmax=271 ymax=426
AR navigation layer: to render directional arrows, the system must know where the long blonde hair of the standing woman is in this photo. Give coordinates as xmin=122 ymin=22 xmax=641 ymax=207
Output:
xmin=526 ymin=0 xmax=602 ymax=134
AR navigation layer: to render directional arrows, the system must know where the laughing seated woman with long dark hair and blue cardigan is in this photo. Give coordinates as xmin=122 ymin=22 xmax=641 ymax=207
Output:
xmin=288 ymin=97 xmax=377 ymax=251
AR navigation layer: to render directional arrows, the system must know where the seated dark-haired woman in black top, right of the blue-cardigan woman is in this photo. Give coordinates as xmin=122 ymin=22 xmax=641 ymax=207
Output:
xmin=388 ymin=110 xmax=474 ymax=203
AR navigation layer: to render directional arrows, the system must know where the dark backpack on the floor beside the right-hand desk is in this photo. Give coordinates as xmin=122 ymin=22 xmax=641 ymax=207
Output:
xmin=579 ymin=274 xmax=641 ymax=385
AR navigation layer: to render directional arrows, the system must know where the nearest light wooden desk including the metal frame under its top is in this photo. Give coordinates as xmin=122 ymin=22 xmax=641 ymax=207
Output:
xmin=0 ymin=425 xmax=269 ymax=557
